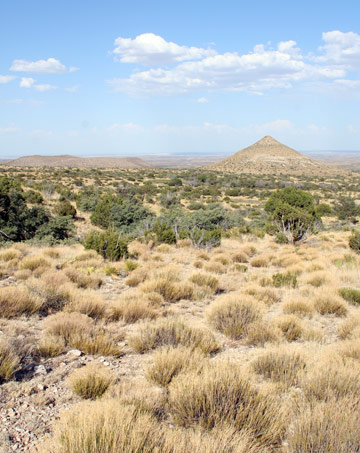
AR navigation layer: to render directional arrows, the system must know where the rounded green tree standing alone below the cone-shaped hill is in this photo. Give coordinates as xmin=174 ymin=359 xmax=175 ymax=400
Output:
xmin=265 ymin=187 xmax=319 ymax=244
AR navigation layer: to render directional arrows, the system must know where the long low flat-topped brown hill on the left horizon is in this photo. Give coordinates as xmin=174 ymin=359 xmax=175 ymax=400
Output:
xmin=3 ymin=155 xmax=151 ymax=168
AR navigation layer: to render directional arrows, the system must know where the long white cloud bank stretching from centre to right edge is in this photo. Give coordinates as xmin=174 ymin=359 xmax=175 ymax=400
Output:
xmin=107 ymin=31 xmax=360 ymax=99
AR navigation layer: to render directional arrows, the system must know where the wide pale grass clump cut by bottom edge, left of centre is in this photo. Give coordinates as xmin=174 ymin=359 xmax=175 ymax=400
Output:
xmin=43 ymin=399 xmax=163 ymax=453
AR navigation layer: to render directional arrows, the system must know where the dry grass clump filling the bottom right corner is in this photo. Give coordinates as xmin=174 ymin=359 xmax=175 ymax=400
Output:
xmin=287 ymin=398 xmax=360 ymax=453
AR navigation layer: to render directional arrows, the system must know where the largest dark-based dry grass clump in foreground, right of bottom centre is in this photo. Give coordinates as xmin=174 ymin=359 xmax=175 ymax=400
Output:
xmin=169 ymin=362 xmax=284 ymax=446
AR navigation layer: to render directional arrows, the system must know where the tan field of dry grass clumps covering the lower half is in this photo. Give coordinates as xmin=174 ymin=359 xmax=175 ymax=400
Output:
xmin=0 ymin=232 xmax=360 ymax=453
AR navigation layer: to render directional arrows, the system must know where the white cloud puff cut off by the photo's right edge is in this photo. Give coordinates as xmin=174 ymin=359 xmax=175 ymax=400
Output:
xmin=315 ymin=30 xmax=360 ymax=70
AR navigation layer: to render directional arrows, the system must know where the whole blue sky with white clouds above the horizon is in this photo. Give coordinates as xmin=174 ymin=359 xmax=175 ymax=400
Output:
xmin=0 ymin=0 xmax=360 ymax=158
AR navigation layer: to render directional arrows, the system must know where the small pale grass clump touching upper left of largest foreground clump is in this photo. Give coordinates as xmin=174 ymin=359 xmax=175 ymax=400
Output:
xmin=146 ymin=345 xmax=205 ymax=387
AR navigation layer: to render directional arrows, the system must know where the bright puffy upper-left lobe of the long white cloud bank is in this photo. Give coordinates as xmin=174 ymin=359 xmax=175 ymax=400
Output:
xmin=113 ymin=33 xmax=216 ymax=66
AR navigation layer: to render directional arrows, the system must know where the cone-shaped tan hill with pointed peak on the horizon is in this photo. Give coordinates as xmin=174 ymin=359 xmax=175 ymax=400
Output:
xmin=206 ymin=135 xmax=347 ymax=176
